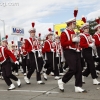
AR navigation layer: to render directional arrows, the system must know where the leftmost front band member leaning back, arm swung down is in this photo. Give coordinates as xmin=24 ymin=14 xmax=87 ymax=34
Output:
xmin=0 ymin=37 xmax=21 ymax=90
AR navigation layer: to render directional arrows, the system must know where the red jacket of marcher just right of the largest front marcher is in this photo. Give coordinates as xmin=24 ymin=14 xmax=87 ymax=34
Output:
xmin=80 ymin=33 xmax=92 ymax=48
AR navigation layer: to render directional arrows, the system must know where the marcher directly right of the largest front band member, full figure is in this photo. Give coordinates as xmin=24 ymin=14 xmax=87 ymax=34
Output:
xmin=80 ymin=17 xmax=100 ymax=85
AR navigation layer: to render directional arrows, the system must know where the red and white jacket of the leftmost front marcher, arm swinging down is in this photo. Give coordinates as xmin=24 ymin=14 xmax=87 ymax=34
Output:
xmin=0 ymin=46 xmax=17 ymax=64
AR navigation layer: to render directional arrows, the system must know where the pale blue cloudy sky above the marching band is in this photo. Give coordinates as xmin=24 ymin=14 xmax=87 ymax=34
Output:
xmin=0 ymin=0 xmax=100 ymax=40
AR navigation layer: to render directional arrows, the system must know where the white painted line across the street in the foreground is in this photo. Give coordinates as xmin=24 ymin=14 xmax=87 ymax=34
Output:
xmin=0 ymin=90 xmax=59 ymax=93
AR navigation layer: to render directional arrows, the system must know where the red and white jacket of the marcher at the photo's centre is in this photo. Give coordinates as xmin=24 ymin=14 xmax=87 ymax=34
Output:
xmin=42 ymin=39 xmax=56 ymax=53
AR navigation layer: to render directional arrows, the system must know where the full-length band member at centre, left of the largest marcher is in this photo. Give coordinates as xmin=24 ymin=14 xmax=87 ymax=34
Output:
xmin=43 ymin=28 xmax=60 ymax=80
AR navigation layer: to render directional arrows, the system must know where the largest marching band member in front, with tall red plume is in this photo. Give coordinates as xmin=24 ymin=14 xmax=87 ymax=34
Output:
xmin=58 ymin=10 xmax=87 ymax=93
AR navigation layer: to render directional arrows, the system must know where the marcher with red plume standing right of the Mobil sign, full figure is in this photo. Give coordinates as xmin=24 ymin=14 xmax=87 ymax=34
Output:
xmin=24 ymin=23 xmax=45 ymax=84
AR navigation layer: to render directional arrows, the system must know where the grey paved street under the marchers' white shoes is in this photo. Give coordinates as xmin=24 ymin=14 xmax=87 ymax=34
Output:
xmin=0 ymin=73 xmax=100 ymax=100
